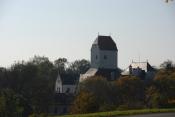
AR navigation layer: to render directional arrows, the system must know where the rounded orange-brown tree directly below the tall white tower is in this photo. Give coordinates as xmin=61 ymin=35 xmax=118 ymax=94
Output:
xmin=72 ymin=76 xmax=118 ymax=113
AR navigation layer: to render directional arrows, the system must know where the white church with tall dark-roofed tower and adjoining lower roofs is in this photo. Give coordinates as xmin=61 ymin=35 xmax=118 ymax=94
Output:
xmin=80 ymin=35 xmax=120 ymax=81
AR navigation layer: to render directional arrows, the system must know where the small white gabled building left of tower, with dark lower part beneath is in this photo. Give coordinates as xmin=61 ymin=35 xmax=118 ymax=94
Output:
xmin=49 ymin=73 xmax=78 ymax=115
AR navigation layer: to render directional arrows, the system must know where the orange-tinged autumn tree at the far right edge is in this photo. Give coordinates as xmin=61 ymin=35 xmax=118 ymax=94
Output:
xmin=146 ymin=68 xmax=175 ymax=108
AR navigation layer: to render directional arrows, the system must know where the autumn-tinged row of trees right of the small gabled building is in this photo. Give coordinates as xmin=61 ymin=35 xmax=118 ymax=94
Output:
xmin=70 ymin=60 xmax=175 ymax=114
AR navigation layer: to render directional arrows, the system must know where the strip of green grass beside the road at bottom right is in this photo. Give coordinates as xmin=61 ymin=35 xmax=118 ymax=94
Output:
xmin=52 ymin=108 xmax=175 ymax=117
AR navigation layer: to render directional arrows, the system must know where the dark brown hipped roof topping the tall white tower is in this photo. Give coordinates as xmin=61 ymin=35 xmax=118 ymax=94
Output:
xmin=92 ymin=35 xmax=117 ymax=50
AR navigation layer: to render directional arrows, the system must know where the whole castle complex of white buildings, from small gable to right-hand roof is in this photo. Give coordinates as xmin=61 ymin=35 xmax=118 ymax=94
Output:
xmin=50 ymin=35 xmax=155 ymax=114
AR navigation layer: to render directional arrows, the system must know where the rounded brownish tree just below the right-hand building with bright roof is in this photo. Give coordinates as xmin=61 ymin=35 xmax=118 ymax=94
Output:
xmin=116 ymin=76 xmax=144 ymax=109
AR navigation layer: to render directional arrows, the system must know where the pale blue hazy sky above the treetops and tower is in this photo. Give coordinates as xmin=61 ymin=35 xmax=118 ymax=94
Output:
xmin=0 ymin=0 xmax=175 ymax=69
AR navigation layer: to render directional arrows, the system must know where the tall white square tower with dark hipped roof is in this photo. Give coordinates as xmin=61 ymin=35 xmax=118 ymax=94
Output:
xmin=91 ymin=36 xmax=118 ymax=69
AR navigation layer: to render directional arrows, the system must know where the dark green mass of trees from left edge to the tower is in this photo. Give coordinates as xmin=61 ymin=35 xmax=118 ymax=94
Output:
xmin=0 ymin=56 xmax=90 ymax=117
